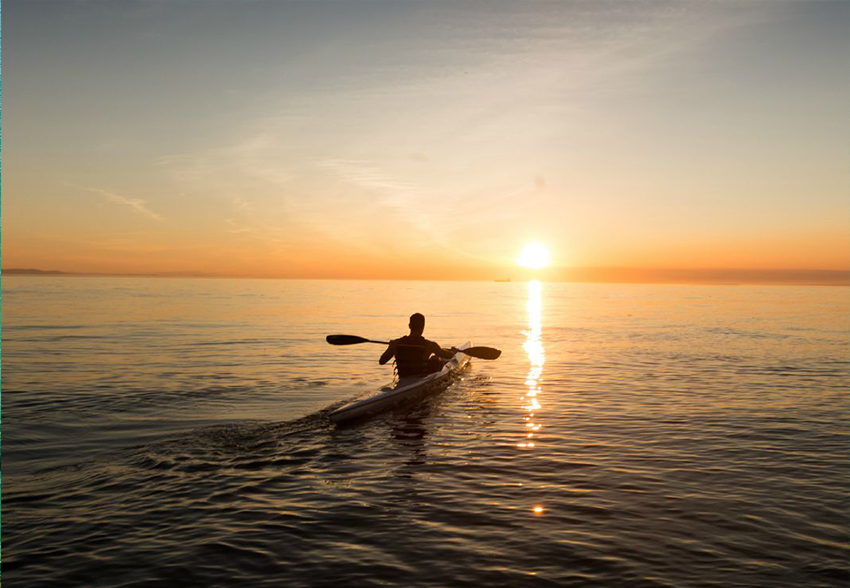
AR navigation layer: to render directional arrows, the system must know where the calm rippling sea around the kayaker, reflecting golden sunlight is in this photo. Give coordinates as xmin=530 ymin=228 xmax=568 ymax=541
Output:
xmin=2 ymin=276 xmax=850 ymax=588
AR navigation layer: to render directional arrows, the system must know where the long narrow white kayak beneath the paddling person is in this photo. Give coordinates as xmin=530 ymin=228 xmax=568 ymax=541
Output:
xmin=328 ymin=341 xmax=472 ymax=423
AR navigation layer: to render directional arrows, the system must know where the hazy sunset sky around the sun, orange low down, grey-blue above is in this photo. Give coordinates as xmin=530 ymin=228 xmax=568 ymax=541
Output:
xmin=2 ymin=0 xmax=850 ymax=279
